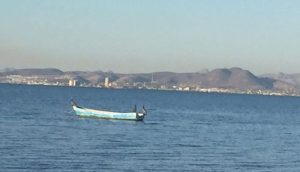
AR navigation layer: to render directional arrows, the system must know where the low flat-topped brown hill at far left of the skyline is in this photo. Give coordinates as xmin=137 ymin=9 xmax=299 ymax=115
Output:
xmin=2 ymin=68 xmax=64 ymax=76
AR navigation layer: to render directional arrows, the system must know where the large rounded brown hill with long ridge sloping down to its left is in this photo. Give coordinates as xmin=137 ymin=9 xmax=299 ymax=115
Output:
xmin=112 ymin=68 xmax=275 ymax=90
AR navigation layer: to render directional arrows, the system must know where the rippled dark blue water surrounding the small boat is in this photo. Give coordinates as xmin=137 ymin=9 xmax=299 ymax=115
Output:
xmin=0 ymin=84 xmax=300 ymax=172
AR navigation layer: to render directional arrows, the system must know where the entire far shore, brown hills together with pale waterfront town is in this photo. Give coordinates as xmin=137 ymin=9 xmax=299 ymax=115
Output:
xmin=0 ymin=67 xmax=300 ymax=96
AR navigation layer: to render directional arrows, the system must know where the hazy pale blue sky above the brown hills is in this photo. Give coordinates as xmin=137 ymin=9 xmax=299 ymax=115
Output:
xmin=0 ymin=0 xmax=300 ymax=74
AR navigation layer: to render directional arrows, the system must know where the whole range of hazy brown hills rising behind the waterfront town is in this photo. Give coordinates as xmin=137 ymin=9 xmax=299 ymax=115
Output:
xmin=0 ymin=68 xmax=300 ymax=90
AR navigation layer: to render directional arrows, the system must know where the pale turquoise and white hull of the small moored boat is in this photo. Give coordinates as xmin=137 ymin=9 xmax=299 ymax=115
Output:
xmin=72 ymin=106 xmax=145 ymax=121
